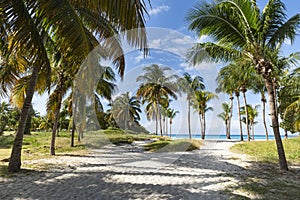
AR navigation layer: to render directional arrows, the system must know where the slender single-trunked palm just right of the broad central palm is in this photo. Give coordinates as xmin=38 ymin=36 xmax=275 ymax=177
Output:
xmin=178 ymin=73 xmax=205 ymax=139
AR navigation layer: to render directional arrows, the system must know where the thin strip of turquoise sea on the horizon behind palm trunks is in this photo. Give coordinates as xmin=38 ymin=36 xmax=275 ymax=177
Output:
xmin=172 ymin=133 xmax=299 ymax=140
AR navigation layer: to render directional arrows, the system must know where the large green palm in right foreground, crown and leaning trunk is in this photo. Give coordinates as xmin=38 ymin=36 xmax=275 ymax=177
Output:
xmin=187 ymin=0 xmax=300 ymax=170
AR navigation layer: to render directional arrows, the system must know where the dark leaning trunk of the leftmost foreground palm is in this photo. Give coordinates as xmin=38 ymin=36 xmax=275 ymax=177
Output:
xmin=8 ymin=65 xmax=40 ymax=172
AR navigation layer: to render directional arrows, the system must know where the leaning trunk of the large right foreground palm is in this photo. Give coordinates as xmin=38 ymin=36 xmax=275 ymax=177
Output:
xmin=264 ymin=76 xmax=288 ymax=171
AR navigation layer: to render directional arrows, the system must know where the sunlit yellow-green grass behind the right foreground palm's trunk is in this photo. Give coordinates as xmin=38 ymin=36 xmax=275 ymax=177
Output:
xmin=231 ymin=137 xmax=300 ymax=164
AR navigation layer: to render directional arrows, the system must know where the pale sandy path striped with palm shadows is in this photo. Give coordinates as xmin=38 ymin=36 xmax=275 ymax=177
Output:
xmin=0 ymin=141 xmax=256 ymax=200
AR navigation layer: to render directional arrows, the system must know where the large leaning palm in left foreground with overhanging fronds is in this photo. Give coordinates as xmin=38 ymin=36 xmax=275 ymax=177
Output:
xmin=0 ymin=0 xmax=151 ymax=172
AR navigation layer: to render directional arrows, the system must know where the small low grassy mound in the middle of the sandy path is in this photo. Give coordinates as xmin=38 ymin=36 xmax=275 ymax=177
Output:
xmin=144 ymin=139 xmax=202 ymax=152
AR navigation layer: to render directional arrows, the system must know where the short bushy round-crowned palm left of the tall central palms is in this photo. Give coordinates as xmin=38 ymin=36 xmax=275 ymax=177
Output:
xmin=111 ymin=92 xmax=142 ymax=130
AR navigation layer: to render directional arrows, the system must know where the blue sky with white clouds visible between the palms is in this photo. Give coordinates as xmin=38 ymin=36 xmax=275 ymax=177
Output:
xmin=26 ymin=0 xmax=300 ymax=135
